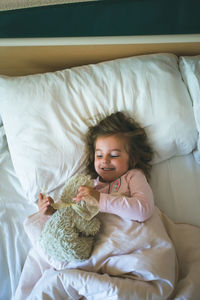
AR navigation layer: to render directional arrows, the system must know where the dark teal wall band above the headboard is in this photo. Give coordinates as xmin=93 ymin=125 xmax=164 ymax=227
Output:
xmin=0 ymin=0 xmax=200 ymax=38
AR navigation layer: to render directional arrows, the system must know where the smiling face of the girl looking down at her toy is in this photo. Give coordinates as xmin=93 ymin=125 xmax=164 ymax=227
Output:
xmin=94 ymin=134 xmax=129 ymax=182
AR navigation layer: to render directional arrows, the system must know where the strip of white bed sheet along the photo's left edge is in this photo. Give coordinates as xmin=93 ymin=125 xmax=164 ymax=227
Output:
xmin=0 ymin=127 xmax=36 ymax=300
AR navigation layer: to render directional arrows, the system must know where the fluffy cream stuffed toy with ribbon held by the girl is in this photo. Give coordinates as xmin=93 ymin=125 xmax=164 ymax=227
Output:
xmin=40 ymin=174 xmax=100 ymax=262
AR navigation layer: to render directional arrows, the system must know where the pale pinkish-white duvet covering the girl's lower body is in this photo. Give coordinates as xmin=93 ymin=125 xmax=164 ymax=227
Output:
xmin=15 ymin=208 xmax=200 ymax=300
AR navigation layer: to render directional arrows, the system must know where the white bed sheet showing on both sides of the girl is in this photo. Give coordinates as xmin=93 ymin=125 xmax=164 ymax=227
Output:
xmin=0 ymin=127 xmax=200 ymax=300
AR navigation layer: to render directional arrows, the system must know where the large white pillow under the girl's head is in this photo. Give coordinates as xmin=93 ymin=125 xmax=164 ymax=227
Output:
xmin=0 ymin=54 xmax=197 ymax=201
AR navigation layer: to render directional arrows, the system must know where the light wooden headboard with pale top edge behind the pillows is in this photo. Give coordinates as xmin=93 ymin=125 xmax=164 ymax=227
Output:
xmin=0 ymin=34 xmax=200 ymax=76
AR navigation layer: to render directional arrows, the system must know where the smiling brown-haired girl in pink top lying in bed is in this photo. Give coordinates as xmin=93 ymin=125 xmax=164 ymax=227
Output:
xmin=38 ymin=112 xmax=154 ymax=222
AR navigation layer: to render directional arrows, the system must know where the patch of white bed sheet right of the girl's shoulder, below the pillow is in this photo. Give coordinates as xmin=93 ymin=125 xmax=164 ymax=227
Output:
xmin=151 ymin=153 xmax=200 ymax=227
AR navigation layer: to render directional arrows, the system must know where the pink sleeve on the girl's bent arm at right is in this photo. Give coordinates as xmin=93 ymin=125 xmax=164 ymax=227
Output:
xmin=99 ymin=171 xmax=154 ymax=222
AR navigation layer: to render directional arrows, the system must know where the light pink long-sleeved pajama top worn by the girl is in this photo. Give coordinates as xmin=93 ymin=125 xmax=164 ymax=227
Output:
xmin=94 ymin=169 xmax=154 ymax=222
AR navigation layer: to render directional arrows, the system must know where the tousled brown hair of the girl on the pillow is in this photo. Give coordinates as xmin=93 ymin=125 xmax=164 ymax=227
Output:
xmin=86 ymin=112 xmax=153 ymax=179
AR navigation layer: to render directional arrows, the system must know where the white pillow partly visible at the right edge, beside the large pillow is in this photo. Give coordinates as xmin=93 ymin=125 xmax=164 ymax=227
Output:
xmin=179 ymin=55 xmax=200 ymax=164
